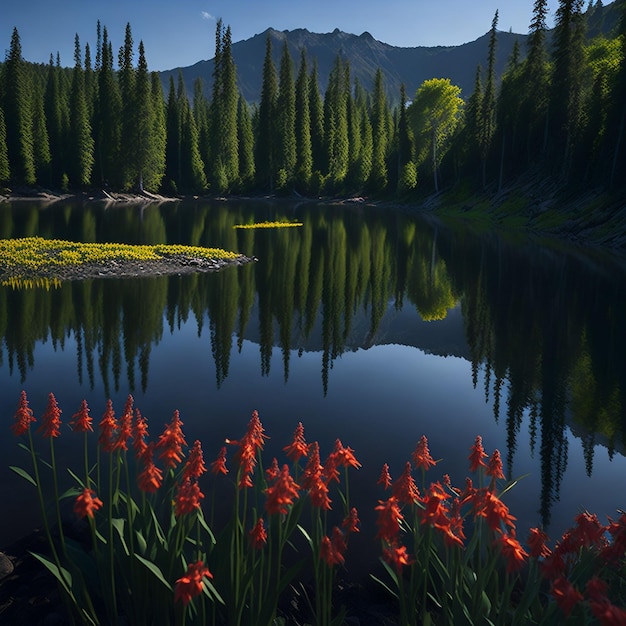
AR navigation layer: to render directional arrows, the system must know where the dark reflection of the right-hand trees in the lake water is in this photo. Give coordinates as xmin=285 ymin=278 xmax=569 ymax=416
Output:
xmin=440 ymin=225 xmax=626 ymax=524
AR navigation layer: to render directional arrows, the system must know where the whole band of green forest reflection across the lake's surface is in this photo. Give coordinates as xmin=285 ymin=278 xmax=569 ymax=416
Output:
xmin=0 ymin=201 xmax=626 ymax=523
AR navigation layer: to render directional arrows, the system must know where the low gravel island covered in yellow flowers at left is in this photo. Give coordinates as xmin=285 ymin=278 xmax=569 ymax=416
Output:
xmin=0 ymin=237 xmax=255 ymax=285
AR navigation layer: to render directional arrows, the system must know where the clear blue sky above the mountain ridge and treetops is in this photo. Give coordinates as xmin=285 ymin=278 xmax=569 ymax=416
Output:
xmin=0 ymin=0 xmax=584 ymax=70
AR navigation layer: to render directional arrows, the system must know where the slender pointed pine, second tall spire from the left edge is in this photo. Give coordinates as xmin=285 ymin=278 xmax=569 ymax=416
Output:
xmin=68 ymin=34 xmax=94 ymax=187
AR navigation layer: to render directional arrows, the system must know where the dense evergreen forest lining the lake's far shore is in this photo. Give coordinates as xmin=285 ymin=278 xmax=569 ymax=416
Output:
xmin=0 ymin=0 xmax=626 ymax=200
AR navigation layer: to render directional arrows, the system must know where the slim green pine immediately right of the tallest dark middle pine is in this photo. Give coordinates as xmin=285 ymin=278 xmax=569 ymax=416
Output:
xmin=275 ymin=41 xmax=296 ymax=186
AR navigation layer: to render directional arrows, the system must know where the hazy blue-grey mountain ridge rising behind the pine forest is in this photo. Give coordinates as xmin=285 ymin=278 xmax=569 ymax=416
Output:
xmin=160 ymin=2 xmax=620 ymax=103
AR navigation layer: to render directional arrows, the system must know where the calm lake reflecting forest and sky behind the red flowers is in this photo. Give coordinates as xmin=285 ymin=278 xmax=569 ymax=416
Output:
xmin=0 ymin=200 xmax=626 ymax=572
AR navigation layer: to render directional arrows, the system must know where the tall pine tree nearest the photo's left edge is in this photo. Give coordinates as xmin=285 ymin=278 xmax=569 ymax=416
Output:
xmin=3 ymin=28 xmax=36 ymax=185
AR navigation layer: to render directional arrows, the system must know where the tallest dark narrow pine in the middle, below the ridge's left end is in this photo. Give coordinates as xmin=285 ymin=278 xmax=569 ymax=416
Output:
xmin=255 ymin=33 xmax=278 ymax=190
